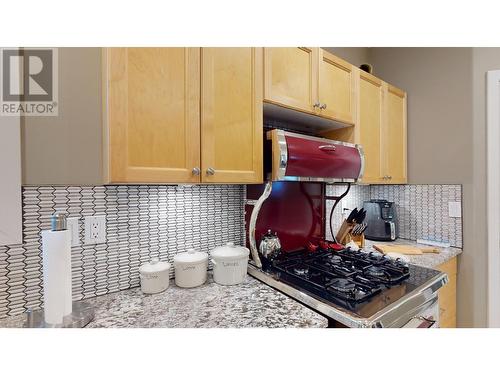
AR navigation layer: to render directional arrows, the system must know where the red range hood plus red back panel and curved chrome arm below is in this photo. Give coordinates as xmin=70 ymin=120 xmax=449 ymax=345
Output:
xmin=246 ymin=129 xmax=364 ymax=268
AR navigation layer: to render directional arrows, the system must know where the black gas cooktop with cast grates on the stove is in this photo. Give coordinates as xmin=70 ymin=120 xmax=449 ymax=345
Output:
xmin=258 ymin=248 xmax=446 ymax=319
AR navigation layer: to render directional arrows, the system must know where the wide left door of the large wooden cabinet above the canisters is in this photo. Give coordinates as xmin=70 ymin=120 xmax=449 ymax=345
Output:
xmin=105 ymin=48 xmax=200 ymax=183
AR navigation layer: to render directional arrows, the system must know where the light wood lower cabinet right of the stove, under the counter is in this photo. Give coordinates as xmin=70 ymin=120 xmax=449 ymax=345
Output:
xmin=437 ymin=257 xmax=457 ymax=328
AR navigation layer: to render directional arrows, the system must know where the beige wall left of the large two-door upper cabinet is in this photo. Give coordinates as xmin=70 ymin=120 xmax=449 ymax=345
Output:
xmin=21 ymin=48 xmax=102 ymax=185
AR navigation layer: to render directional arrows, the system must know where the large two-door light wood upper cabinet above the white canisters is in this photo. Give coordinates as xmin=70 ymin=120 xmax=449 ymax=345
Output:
xmin=103 ymin=48 xmax=263 ymax=183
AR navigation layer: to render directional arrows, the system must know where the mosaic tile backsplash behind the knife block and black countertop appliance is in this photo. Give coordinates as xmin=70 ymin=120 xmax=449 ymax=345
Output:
xmin=326 ymin=185 xmax=462 ymax=248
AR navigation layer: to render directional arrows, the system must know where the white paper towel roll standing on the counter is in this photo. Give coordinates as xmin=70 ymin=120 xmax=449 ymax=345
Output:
xmin=42 ymin=230 xmax=72 ymax=324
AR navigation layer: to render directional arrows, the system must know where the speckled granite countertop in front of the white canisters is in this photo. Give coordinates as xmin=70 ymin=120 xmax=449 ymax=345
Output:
xmin=0 ymin=275 xmax=328 ymax=328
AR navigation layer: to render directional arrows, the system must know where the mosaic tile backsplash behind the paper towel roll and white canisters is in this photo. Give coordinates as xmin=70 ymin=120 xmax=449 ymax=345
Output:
xmin=0 ymin=185 xmax=245 ymax=318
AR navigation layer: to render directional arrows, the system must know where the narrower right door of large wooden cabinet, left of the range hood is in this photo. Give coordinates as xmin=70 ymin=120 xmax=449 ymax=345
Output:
xmin=201 ymin=48 xmax=263 ymax=183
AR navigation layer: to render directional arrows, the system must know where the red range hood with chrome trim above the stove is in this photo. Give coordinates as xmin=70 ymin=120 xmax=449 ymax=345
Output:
xmin=266 ymin=129 xmax=364 ymax=183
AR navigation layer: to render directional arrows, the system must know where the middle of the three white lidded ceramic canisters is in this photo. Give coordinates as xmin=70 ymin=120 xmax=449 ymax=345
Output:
xmin=174 ymin=249 xmax=208 ymax=288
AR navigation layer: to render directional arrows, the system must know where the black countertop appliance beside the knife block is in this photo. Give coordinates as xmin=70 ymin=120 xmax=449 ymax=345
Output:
xmin=363 ymin=199 xmax=399 ymax=241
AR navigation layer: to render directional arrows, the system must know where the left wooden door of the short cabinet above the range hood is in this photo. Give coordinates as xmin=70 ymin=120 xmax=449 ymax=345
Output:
xmin=264 ymin=47 xmax=319 ymax=113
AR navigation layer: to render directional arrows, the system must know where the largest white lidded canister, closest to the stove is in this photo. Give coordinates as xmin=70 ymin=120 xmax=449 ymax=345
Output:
xmin=210 ymin=242 xmax=250 ymax=285
